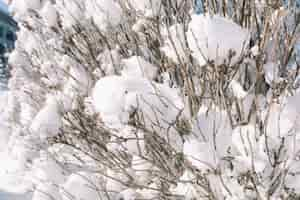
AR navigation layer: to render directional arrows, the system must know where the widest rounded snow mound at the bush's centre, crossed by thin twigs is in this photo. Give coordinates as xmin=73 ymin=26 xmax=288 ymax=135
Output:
xmin=93 ymin=76 xmax=183 ymax=130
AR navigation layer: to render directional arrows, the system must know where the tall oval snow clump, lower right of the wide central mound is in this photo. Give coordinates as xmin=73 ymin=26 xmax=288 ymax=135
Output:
xmin=183 ymin=108 xmax=232 ymax=170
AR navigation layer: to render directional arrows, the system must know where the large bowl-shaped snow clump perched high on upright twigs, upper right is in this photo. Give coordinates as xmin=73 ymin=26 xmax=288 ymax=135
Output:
xmin=187 ymin=14 xmax=249 ymax=65
